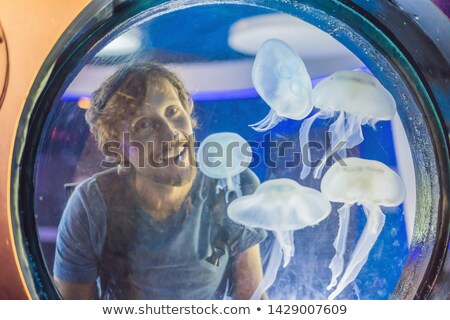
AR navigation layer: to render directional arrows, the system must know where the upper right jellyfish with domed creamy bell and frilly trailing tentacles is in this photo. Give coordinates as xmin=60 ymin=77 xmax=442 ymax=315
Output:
xmin=300 ymin=70 xmax=397 ymax=179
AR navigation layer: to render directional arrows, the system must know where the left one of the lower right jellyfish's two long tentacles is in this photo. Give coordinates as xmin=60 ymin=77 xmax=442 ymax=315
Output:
xmin=327 ymin=203 xmax=352 ymax=290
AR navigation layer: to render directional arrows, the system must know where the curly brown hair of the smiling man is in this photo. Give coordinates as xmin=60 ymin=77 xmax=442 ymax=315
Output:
xmin=85 ymin=63 xmax=195 ymax=150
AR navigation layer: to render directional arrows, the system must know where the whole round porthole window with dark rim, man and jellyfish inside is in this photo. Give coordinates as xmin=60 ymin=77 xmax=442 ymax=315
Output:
xmin=8 ymin=0 xmax=450 ymax=299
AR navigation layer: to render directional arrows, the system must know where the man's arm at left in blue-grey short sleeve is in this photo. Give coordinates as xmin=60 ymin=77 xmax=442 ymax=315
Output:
xmin=53 ymin=182 xmax=106 ymax=300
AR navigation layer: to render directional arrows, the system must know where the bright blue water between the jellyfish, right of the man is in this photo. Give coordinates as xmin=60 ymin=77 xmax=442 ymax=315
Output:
xmin=195 ymin=99 xmax=408 ymax=299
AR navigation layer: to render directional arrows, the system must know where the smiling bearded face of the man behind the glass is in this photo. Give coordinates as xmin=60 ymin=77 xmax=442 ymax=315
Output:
xmin=123 ymin=79 xmax=195 ymax=186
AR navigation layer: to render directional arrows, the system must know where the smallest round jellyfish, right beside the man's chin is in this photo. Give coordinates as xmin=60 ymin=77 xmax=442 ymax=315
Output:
xmin=197 ymin=132 xmax=252 ymax=202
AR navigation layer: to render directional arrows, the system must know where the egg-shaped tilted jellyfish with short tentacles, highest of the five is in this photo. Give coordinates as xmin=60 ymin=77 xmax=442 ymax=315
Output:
xmin=250 ymin=39 xmax=312 ymax=132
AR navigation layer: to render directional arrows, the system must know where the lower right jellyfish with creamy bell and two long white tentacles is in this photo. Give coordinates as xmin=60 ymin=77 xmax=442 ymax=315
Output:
xmin=320 ymin=158 xmax=406 ymax=300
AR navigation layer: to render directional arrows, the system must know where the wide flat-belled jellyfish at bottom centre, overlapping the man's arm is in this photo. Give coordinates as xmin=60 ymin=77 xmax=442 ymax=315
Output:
xmin=228 ymin=178 xmax=331 ymax=299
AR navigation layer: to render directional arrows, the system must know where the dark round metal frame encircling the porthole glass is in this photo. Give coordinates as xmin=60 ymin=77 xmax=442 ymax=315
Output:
xmin=4 ymin=0 xmax=450 ymax=299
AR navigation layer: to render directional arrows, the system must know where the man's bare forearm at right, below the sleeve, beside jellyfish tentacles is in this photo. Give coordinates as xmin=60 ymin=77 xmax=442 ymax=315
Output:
xmin=233 ymin=244 xmax=267 ymax=300
